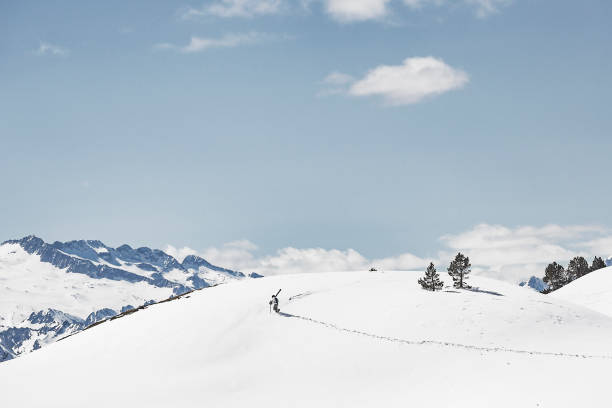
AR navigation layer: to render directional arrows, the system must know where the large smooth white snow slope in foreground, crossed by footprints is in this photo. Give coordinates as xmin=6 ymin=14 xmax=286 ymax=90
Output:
xmin=0 ymin=272 xmax=612 ymax=408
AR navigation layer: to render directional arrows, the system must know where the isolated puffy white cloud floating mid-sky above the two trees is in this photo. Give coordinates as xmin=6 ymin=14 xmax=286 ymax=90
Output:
xmin=347 ymin=57 xmax=469 ymax=105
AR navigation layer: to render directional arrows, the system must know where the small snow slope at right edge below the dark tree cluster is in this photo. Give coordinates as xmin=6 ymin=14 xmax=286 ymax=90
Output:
xmin=549 ymin=266 xmax=612 ymax=316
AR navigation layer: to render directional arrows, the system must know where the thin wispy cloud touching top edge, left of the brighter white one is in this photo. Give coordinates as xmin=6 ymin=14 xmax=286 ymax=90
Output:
xmin=180 ymin=0 xmax=284 ymax=19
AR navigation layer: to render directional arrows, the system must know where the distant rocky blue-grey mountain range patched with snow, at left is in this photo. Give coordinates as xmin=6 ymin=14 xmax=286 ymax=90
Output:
xmin=0 ymin=236 xmax=256 ymax=361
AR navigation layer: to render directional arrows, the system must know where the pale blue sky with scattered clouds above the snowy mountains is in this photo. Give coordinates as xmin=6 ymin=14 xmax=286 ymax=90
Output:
xmin=0 ymin=0 xmax=612 ymax=279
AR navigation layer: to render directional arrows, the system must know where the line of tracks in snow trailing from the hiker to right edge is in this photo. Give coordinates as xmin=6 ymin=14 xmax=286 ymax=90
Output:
xmin=278 ymin=312 xmax=612 ymax=360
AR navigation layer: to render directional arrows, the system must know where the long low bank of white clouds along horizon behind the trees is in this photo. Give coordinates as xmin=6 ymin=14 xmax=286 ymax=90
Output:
xmin=166 ymin=224 xmax=612 ymax=283
